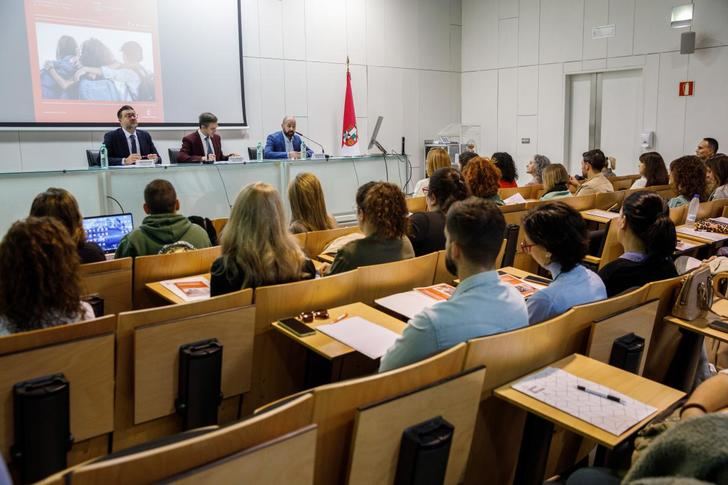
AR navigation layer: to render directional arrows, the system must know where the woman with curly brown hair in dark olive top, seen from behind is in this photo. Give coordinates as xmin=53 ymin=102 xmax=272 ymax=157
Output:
xmin=328 ymin=182 xmax=415 ymax=274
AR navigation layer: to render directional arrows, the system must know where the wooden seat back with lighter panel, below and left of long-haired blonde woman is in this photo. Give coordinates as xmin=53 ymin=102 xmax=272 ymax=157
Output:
xmin=113 ymin=289 xmax=255 ymax=450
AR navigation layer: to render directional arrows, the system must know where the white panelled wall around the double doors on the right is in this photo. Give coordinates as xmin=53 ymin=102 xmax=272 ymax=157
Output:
xmin=462 ymin=0 xmax=728 ymax=179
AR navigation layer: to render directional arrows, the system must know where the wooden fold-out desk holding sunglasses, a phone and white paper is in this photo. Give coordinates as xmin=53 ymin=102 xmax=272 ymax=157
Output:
xmin=273 ymin=303 xmax=407 ymax=360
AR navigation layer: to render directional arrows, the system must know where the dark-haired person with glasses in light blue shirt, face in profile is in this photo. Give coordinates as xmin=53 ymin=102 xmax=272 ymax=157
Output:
xmin=521 ymin=202 xmax=607 ymax=325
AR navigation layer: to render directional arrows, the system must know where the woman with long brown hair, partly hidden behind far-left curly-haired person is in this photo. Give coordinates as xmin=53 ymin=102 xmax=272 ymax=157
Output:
xmin=30 ymin=187 xmax=106 ymax=264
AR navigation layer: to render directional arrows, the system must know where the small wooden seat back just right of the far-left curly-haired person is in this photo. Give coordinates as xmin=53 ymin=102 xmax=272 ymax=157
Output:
xmin=81 ymin=258 xmax=133 ymax=315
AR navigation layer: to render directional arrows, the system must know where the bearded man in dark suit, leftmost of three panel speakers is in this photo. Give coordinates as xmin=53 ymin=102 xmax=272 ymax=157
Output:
xmin=104 ymin=105 xmax=159 ymax=165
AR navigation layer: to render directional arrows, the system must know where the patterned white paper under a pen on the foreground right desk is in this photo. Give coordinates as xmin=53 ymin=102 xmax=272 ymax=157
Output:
xmin=512 ymin=367 xmax=657 ymax=436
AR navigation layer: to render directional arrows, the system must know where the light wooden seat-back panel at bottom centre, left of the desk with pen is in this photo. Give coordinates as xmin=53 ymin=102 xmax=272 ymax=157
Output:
xmin=347 ymin=367 xmax=485 ymax=485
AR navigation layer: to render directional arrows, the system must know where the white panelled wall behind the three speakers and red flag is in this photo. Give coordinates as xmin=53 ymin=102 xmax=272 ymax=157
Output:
xmin=0 ymin=0 xmax=461 ymax=183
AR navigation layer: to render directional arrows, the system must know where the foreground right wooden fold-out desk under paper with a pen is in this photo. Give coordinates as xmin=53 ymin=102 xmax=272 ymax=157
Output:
xmin=495 ymin=354 xmax=685 ymax=484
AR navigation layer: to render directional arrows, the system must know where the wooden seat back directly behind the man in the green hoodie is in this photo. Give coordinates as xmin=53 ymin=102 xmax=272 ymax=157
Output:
xmin=134 ymin=246 xmax=220 ymax=309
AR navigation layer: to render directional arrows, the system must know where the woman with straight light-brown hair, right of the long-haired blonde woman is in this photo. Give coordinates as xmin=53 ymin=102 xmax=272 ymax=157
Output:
xmin=288 ymin=173 xmax=336 ymax=234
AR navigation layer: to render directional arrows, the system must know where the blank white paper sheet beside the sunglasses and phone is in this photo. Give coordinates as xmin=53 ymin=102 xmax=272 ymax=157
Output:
xmin=316 ymin=317 xmax=399 ymax=359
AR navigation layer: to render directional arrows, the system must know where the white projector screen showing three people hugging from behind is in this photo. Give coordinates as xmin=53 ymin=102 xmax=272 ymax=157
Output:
xmin=0 ymin=0 xmax=246 ymax=127
